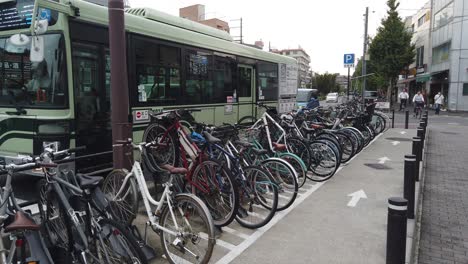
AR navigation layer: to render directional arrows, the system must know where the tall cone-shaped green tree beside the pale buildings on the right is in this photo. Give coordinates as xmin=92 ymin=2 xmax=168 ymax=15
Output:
xmin=369 ymin=0 xmax=416 ymax=101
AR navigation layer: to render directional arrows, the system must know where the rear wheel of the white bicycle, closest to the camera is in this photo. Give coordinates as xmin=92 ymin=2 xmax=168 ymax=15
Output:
xmin=159 ymin=194 xmax=215 ymax=263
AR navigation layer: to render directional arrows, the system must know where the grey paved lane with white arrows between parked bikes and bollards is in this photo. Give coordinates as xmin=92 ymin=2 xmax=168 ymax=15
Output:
xmin=133 ymin=129 xmax=415 ymax=264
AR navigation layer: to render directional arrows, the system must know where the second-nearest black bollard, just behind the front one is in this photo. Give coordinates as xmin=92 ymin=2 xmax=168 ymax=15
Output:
xmin=403 ymin=155 xmax=419 ymax=219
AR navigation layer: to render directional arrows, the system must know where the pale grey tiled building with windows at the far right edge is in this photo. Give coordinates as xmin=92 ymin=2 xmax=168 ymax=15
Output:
xmin=430 ymin=0 xmax=468 ymax=111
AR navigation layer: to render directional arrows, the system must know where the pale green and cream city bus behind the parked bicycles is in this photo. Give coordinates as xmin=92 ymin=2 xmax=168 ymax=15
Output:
xmin=0 ymin=0 xmax=297 ymax=171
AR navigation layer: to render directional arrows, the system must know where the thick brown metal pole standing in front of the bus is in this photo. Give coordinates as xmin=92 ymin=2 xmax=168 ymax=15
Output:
xmin=109 ymin=0 xmax=132 ymax=169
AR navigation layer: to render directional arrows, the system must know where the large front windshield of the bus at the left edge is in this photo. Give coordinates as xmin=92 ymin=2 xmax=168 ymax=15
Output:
xmin=0 ymin=34 xmax=68 ymax=108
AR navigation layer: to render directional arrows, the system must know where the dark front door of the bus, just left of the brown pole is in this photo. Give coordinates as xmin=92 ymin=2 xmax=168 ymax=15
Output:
xmin=72 ymin=43 xmax=112 ymax=172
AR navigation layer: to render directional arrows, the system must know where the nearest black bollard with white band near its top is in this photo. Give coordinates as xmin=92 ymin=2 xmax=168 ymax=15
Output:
xmin=386 ymin=197 xmax=408 ymax=264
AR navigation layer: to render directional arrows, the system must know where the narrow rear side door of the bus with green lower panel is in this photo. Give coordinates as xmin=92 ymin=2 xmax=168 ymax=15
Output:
xmin=237 ymin=65 xmax=255 ymax=120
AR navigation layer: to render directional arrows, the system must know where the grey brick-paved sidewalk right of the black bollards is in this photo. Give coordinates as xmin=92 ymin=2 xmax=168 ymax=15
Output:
xmin=418 ymin=122 xmax=468 ymax=264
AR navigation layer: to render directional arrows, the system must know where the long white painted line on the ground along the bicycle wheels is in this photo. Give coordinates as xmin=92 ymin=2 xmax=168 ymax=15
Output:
xmin=216 ymin=133 xmax=383 ymax=264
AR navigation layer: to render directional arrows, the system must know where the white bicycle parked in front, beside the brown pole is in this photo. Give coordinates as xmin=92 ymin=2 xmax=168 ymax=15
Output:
xmin=102 ymin=139 xmax=216 ymax=263
